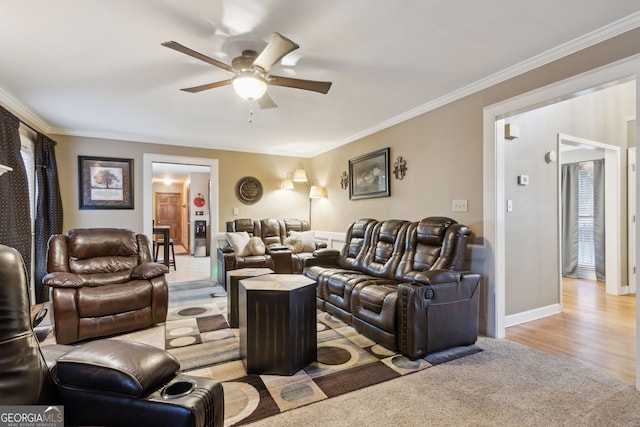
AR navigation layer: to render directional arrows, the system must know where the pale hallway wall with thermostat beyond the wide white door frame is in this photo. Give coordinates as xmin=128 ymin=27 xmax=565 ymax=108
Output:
xmin=505 ymin=82 xmax=635 ymax=315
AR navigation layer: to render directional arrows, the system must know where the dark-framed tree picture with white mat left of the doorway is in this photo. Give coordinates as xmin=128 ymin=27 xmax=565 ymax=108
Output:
xmin=78 ymin=156 xmax=133 ymax=209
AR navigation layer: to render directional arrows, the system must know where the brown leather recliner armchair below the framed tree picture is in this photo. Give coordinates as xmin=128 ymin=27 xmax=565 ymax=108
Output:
xmin=43 ymin=228 xmax=168 ymax=344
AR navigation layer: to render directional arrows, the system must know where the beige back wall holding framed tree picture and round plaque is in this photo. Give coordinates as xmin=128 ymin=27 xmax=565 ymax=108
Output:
xmin=52 ymin=135 xmax=309 ymax=236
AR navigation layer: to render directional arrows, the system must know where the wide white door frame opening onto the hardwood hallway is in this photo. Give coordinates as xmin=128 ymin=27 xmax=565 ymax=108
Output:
xmin=483 ymin=55 xmax=640 ymax=344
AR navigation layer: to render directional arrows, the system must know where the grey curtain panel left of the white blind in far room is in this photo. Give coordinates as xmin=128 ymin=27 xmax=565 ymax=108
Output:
xmin=561 ymin=163 xmax=578 ymax=279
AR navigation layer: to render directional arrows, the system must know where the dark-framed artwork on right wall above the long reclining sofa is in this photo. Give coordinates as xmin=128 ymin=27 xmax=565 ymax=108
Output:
xmin=349 ymin=147 xmax=391 ymax=200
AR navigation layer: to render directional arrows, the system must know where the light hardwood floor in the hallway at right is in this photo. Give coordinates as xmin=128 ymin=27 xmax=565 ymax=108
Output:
xmin=506 ymin=279 xmax=636 ymax=384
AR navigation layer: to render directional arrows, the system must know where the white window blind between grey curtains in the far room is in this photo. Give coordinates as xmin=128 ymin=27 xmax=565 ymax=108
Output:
xmin=578 ymin=162 xmax=596 ymax=280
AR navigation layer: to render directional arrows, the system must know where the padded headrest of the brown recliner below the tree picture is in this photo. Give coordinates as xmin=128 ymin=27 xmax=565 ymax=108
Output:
xmin=67 ymin=228 xmax=138 ymax=260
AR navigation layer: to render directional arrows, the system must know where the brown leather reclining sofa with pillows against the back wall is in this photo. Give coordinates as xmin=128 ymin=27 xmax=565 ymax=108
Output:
xmin=218 ymin=218 xmax=327 ymax=284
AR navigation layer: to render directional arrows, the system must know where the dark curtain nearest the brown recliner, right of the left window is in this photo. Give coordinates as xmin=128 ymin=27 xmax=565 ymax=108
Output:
xmin=34 ymin=133 xmax=62 ymax=303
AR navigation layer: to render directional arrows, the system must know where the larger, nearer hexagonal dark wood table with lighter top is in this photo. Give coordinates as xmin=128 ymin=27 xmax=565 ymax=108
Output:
xmin=238 ymin=274 xmax=318 ymax=375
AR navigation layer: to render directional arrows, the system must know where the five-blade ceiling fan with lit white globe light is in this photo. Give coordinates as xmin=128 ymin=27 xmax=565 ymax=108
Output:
xmin=162 ymin=33 xmax=331 ymax=109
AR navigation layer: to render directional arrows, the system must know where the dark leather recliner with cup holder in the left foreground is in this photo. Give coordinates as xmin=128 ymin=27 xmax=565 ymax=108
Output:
xmin=0 ymin=245 xmax=224 ymax=427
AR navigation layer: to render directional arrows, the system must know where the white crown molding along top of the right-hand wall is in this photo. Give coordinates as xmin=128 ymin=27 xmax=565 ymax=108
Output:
xmin=343 ymin=12 xmax=640 ymax=144
